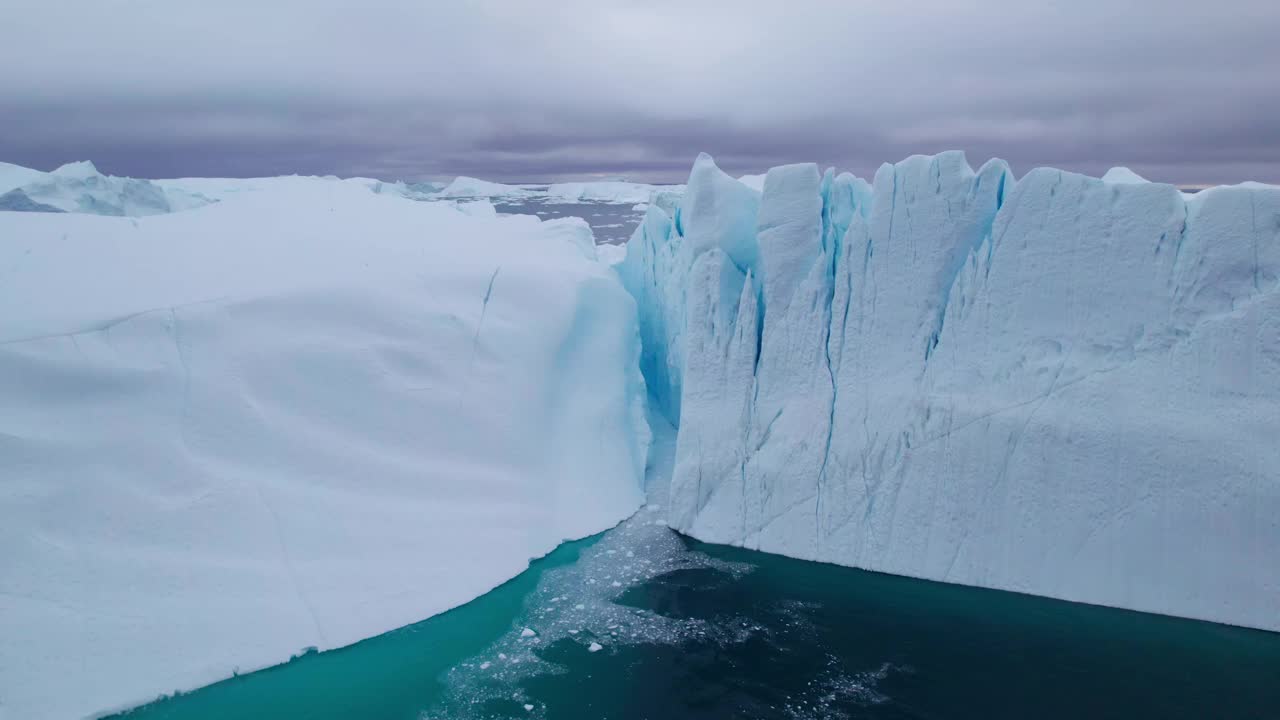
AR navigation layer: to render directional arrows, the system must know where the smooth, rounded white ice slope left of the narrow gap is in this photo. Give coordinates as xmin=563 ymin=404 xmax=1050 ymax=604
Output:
xmin=0 ymin=178 xmax=648 ymax=720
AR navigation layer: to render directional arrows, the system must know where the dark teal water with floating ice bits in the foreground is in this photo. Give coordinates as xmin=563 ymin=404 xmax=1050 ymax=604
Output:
xmin=117 ymin=511 xmax=1280 ymax=720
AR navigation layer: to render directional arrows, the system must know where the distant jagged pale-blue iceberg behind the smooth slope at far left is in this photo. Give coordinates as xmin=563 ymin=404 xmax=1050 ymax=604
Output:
xmin=0 ymin=160 xmax=212 ymax=218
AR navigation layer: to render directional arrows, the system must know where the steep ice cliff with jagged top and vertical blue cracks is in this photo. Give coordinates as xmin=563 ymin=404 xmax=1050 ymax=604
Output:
xmin=620 ymin=152 xmax=1280 ymax=629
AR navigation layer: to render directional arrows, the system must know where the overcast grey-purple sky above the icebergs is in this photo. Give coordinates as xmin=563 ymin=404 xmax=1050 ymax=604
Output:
xmin=0 ymin=0 xmax=1280 ymax=183
